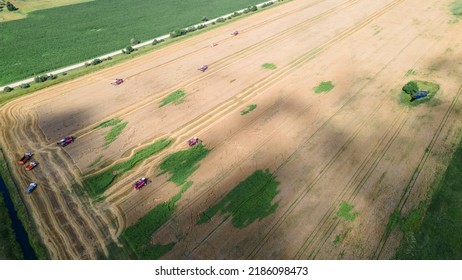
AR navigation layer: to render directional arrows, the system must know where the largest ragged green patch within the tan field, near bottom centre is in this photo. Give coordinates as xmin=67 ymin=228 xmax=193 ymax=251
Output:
xmin=197 ymin=169 xmax=280 ymax=228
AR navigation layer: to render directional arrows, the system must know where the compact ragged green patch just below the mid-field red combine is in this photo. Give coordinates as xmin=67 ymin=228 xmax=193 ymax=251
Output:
xmin=159 ymin=144 xmax=210 ymax=186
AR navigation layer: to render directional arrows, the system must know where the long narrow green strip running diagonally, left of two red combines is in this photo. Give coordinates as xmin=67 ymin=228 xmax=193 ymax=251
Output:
xmin=84 ymin=139 xmax=171 ymax=198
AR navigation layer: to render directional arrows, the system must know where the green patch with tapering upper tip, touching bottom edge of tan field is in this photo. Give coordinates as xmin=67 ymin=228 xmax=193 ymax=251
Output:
xmin=121 ymin=181 xmax=192 ymax=259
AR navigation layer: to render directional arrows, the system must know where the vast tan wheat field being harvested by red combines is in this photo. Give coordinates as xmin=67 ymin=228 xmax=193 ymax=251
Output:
xmin=0 ymin=0 xmax=462 ymax=259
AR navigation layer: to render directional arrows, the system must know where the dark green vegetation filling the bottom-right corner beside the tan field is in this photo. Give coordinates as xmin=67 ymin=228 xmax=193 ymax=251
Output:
xmin=389 ymin=136 xmax=462 ymax=260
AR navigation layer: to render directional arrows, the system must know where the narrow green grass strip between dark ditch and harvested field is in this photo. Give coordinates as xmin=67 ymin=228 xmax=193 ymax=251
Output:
xmin=0 ymin=147 xmax=49 ymax=260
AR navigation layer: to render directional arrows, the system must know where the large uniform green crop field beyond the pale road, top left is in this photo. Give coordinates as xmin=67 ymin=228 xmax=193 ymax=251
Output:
xmin=0 ymin=0 xmax=263 ymax=85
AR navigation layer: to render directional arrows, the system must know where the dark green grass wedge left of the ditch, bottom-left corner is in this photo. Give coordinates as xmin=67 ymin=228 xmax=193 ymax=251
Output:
xmin=0 ymin=193 xmax=23 ymax=260
